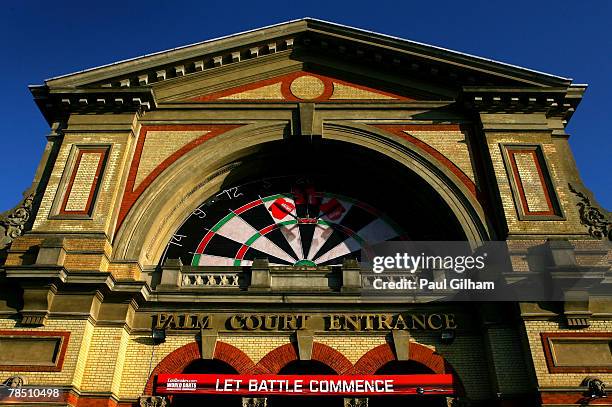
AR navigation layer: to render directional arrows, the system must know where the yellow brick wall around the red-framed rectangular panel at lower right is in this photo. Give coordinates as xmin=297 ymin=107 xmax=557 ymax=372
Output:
xmin=525 ymin=320 xmax=612 ymax=387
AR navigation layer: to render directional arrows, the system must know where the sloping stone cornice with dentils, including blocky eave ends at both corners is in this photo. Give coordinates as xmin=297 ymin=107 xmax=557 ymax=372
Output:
xmin=31 ymin=19 xmax=584 ymax=126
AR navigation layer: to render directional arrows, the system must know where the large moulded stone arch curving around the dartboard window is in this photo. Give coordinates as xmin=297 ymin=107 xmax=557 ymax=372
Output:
xmin=113 ymin=122 xmax=489 ymax=265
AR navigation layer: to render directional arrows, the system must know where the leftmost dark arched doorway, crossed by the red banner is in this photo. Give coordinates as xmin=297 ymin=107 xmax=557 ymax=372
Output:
xmin=171 ymin=359 xmax=242 ymax=407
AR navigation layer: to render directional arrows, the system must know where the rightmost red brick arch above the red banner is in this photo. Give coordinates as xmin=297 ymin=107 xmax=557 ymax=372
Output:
xmin=355 ymin=342 xmax=465 ymax=396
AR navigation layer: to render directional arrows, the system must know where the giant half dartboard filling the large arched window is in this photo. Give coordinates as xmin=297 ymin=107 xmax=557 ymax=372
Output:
xmin=162 ymin=178 xmax=403 ymax=266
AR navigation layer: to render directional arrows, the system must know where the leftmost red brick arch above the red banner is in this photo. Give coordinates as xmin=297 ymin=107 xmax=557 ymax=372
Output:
xmin=144 ymin=342 xmax=260 ymax=394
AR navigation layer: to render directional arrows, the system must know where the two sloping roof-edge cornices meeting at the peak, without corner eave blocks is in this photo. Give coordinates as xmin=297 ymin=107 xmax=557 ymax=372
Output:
xmin=46 ymin=18 xmax=571 ymax=91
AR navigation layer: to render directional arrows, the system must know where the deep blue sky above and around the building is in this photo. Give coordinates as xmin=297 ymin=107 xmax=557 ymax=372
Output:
xmin=0 ymin=0 xmax=612 ymax=212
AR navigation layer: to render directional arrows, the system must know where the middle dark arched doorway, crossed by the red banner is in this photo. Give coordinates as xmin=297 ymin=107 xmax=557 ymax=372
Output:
xmin=268 ymin=360 xmax=344 ymax=407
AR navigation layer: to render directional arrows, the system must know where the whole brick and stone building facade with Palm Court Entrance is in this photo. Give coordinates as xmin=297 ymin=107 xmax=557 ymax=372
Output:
xmin=0 ymin=19 xmax=612 ymax=406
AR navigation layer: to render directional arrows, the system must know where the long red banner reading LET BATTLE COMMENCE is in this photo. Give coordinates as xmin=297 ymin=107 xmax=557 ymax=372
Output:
xmin=155 ymin=374 xmax=454 ymax=396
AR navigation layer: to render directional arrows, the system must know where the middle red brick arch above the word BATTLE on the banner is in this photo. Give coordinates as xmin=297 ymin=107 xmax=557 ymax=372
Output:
xmin=257 ymin=342 xmax=353 ymax=374
